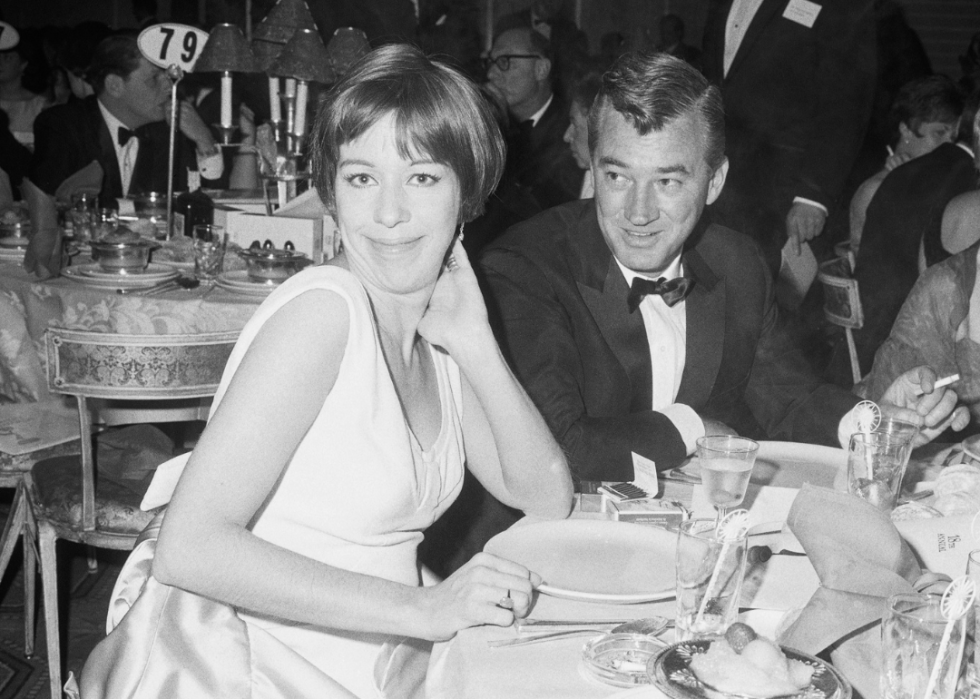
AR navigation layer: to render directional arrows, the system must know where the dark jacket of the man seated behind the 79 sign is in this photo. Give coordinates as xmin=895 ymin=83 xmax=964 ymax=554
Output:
xmin=30 ymin=96 xmax=203 ymax=205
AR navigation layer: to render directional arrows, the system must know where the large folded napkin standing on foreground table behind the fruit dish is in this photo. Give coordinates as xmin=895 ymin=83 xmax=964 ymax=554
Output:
xmin=779 ymin=485 xmax=923 ymax=699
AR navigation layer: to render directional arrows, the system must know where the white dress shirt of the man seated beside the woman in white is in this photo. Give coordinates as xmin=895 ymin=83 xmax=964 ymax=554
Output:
xmin=616 ymin=255 xmax=704 ymax=454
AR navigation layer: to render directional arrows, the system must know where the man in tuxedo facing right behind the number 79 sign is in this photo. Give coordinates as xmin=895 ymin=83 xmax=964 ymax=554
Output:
xmin=30 ymin=34 xmax=224 ymax=205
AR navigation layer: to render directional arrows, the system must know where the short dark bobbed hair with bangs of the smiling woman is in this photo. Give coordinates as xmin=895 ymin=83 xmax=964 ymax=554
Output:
xmin=310 ymin=44 xmax=506 ymax=222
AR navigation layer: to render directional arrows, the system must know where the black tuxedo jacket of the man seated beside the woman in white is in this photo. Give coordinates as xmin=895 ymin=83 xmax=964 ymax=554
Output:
xmin=481 ymin=200 xmax=857 ymax=480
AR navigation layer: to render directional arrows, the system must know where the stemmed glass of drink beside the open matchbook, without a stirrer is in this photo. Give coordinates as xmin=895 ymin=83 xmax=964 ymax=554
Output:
xmin=697 ymin=434 xmax=759 ymax=523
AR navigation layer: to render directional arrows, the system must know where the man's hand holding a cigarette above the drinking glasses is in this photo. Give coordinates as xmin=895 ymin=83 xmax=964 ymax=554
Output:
xmin=879 ymin=366 xmax=970 ymax=447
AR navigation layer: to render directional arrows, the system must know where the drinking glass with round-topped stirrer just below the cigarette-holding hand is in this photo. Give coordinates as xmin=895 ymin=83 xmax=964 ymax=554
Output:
xmin=847 ymin=432 xmax=911 ymax=512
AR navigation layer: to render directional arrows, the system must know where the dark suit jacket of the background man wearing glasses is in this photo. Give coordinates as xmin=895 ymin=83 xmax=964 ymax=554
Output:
xmin=501 ymin=94 xmax=583 ymax=211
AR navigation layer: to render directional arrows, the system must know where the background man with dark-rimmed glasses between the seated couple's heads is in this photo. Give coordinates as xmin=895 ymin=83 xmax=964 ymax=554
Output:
xmin=487 ymin=27 xmax=582 ymax=210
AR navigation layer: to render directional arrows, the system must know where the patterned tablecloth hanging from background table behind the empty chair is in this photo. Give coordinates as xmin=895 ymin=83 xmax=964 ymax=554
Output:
xmin=0 ymin=261 xmax=263 ymax=403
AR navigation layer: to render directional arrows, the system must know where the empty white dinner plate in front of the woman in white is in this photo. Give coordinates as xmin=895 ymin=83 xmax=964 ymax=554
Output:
xmin=484 ymin=519 xmax=677 ymax=604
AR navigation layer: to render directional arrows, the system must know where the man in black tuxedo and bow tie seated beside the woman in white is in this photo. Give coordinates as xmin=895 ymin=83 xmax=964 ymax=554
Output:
xmin=481 ymin=54 xmax=968 ymax=480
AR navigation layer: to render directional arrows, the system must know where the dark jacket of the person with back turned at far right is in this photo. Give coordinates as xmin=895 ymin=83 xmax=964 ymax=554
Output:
xmin=848 ymin=143 xmax=977 ymax=374
